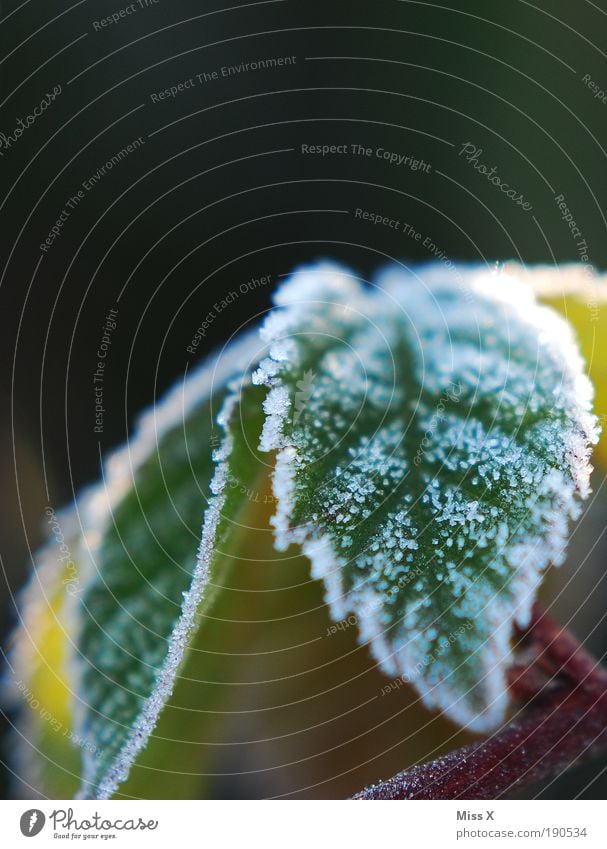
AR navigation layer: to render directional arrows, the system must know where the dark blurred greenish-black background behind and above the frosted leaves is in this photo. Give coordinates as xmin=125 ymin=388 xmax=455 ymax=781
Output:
xmin=0 ymin=0 xmax=607 ymax=798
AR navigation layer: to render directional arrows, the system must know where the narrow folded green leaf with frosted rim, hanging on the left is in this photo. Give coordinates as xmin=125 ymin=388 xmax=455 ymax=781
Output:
xmin=14 ymin=332 xmax=265 ymax=798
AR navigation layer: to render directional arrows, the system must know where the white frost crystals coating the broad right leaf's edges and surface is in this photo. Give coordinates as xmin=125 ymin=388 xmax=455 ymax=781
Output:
xmin=254 ymin=256 xmax=598 ymax=731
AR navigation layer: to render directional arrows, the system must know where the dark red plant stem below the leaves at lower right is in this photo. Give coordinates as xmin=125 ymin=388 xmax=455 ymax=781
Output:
xmin=354 ymin=608 xmax=607 ymax=799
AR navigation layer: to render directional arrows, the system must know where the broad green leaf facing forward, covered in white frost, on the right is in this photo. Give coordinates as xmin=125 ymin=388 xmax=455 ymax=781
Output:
xmin=253 ymin=264 xmax=597 ymax=731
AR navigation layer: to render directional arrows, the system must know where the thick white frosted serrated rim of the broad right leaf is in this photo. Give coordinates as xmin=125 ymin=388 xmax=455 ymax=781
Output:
xmin=253 ymin=263 xmax=598 ymax=733
